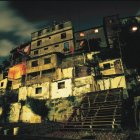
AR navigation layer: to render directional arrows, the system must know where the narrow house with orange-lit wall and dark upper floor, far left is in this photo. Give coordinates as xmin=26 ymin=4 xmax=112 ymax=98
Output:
xmin=8 ymin=42 xmax=30 ymax=90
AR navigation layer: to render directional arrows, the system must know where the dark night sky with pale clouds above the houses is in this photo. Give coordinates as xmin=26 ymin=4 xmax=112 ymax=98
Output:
xmin=0 ymin=0 xmax=140 ymax=63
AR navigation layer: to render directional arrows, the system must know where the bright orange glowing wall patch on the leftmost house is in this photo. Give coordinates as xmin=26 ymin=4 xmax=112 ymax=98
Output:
xmin=8 ymin=62 xmax=26 ymax=79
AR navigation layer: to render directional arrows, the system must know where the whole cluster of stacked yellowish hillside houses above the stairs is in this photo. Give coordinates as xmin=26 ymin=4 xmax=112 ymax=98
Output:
xmin=0 ymin=17 xmax=130 ymax=100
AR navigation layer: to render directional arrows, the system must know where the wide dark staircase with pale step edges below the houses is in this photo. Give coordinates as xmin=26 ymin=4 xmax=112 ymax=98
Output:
xmin=62 ymin=88 xmax=123 ymax=131
